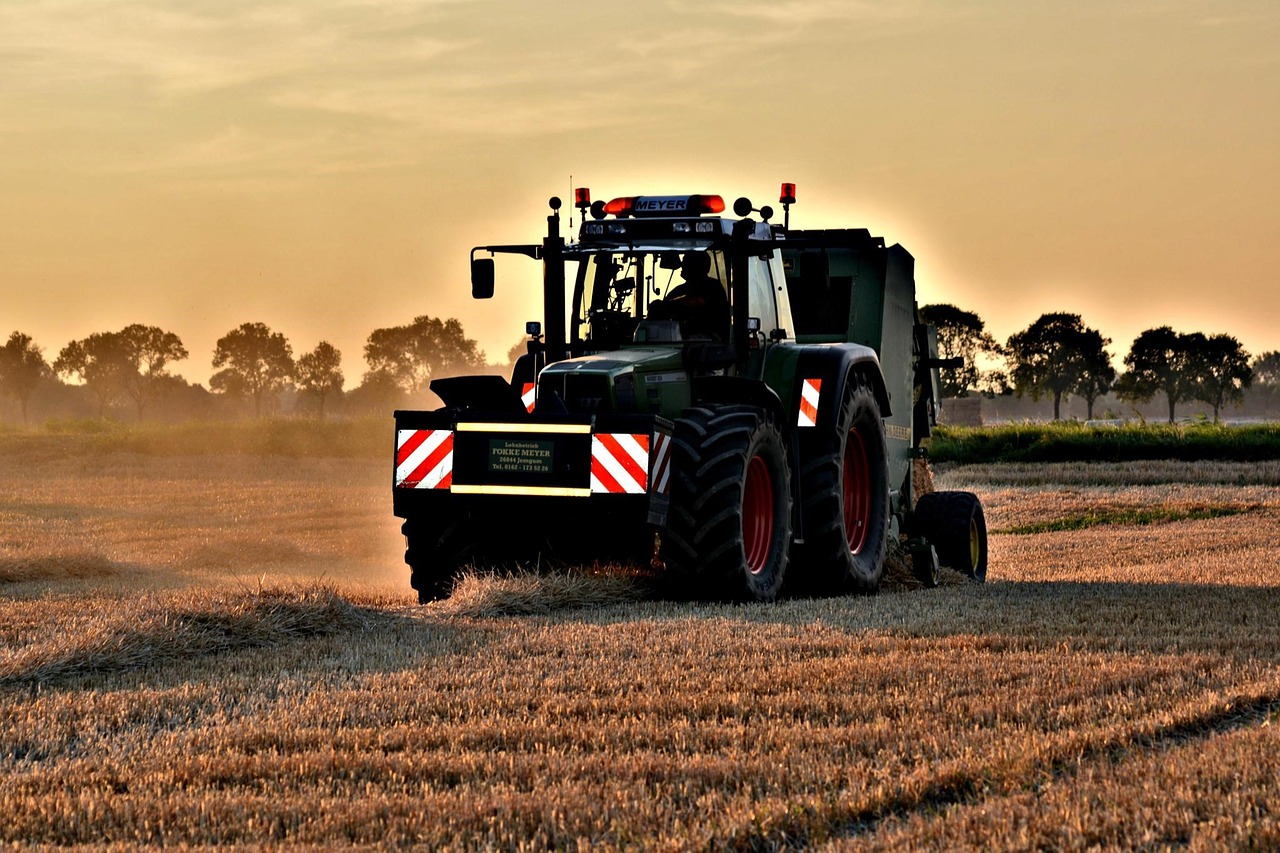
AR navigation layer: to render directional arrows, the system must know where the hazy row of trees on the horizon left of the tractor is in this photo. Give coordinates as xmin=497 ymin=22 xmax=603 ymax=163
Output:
xmin=0 ymin=315 xmax=485 ymax=424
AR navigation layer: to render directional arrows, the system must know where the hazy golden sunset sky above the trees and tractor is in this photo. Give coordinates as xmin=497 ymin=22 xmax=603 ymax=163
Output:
xmin=0 ymin=0 xmax=1280 ymax=388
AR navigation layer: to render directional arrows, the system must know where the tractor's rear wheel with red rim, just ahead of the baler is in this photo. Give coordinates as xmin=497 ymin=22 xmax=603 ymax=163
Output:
xmin=792 ymin=374 xmax=890 ymax=594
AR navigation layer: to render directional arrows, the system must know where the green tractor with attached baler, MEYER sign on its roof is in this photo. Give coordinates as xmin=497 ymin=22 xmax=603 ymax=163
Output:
xmin=393 ymin=183 xmax=987 ymax=602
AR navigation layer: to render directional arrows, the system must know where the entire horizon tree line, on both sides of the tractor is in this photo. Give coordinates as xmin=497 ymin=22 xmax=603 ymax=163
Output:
xmin=0 ymin=305 xmax=1280 ymax=423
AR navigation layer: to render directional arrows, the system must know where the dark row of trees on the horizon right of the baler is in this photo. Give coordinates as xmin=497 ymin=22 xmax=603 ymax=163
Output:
xmin=920 ymin=305 xmax=1280 ymax=423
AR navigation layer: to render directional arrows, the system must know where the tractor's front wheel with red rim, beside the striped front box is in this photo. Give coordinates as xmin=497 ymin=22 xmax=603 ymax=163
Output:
xmin=662 ymin=406 xmax=791 ymax=601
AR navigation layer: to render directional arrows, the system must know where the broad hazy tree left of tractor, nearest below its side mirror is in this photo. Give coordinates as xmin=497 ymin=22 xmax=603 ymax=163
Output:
xmin=365 ymin=315 xmax=485 ymax=394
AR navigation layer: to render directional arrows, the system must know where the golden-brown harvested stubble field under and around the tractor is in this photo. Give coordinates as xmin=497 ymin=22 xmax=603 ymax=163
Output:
xmin=0 ymin=443 xmax=1280 ymax=849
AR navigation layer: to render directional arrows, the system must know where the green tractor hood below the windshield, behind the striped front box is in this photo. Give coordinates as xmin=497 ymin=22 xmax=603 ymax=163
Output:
xmin=538 ymin=346 xmax=690 ymax=416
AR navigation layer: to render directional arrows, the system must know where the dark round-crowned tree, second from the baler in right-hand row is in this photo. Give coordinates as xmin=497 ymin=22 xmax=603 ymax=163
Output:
xmin=1006 ymin=314 xmax=1115 ymax=420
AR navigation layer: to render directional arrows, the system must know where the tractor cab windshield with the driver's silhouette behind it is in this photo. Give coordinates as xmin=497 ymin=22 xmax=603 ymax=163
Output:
xmin=571 ymin=250 xmax=730 ymax=350
